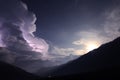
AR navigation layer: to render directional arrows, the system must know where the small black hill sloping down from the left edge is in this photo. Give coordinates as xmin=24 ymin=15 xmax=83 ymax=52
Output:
xmin=0 ymin=61 xmax=37 ymax=80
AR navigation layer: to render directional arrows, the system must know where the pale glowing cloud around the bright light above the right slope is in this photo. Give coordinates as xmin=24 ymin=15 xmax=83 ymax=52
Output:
xmin=53 ymin=6 xmax=120 ymax=55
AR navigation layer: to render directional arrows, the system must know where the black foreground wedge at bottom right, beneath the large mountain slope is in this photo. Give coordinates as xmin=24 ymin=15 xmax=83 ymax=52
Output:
xmin=41 ymin=67 xmax=120 ymax=80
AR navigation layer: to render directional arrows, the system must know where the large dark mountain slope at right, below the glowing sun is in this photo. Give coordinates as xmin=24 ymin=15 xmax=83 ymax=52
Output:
xmin=48 ymin=37 xmax=120 ymax=78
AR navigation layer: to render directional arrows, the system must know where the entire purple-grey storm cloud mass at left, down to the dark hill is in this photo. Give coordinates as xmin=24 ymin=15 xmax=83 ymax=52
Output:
xmin=0 ymin=0 xmax=52 ymax=72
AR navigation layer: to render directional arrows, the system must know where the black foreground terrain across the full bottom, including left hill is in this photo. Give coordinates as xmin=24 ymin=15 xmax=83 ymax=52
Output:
xmin=0 ymin=62 xmax=120 ymax=80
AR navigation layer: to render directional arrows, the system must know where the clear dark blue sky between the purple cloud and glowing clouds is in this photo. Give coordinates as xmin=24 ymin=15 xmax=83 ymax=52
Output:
xmin=23 ymin=0 xmax=119 ymax=47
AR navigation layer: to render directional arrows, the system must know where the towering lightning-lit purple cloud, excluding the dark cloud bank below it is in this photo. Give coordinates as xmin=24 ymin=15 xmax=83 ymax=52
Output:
xmin=0 ymin=0 xmax=49 ymax=57
